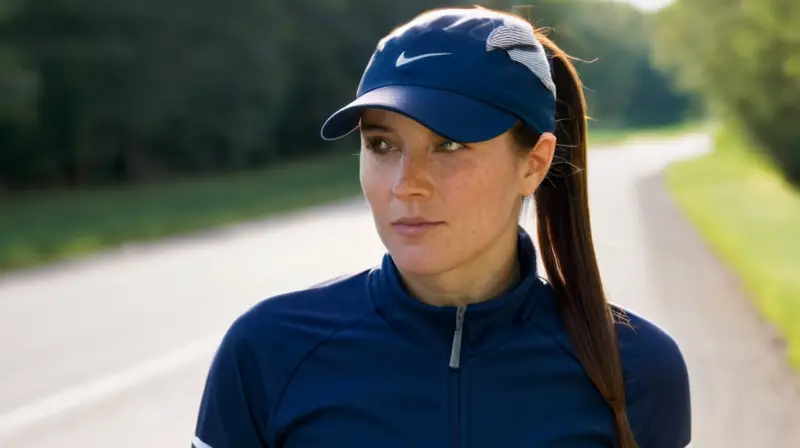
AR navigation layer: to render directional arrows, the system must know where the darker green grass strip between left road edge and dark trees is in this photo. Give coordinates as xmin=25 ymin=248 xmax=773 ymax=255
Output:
xmin=0 ymin=151 xmax=360 ymax=270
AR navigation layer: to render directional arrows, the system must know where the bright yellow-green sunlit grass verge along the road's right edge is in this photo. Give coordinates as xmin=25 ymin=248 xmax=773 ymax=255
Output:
xmin=667 ymin=130 xmax=800 ymax=369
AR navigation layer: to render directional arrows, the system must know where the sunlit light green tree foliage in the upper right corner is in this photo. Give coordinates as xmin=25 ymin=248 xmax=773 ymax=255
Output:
xmin=655 ymin=0 xmax=800 ymax=184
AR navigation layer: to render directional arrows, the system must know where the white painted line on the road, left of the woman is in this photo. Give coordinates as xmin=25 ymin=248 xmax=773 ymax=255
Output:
xmin=0 ymin=338 xmax=220 ymax=437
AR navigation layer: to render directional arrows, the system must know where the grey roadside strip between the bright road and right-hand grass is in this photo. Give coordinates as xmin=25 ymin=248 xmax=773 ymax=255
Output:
xmin=638 ymin=165 xmax=800 ymax=448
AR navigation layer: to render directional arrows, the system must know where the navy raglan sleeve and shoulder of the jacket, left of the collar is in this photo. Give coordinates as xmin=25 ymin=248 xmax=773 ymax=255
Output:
xmin=196 ymin=272 xmax=378 ymax=446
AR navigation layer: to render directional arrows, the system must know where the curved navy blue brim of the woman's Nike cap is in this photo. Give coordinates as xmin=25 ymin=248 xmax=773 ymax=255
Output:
xmin=321 ymin=85 xmax=519 ymax=143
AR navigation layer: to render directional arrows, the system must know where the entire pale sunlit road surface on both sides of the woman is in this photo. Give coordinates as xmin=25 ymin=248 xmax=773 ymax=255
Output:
xmin=0 ymin=135 xmax=800 ymax=448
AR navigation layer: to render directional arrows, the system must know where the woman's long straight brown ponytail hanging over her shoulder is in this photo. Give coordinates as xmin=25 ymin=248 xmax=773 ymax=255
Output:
xmin=512 ymin=27 xmax=638 ymax=448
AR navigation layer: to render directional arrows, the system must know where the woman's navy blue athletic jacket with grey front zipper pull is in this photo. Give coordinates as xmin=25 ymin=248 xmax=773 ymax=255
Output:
xmin=194 ymin=232 xmax=690 ymax=448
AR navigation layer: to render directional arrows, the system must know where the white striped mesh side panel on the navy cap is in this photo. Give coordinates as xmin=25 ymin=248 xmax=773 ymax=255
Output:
xmin=486 ymin=24 xmax=556 ymax=94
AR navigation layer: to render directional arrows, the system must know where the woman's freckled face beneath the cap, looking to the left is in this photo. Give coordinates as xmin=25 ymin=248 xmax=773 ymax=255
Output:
xmin=361 ymin=109 xmax=555 ymax=275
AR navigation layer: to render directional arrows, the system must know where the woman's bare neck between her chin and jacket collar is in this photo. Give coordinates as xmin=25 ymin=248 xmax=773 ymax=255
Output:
xmin=400 ymin=227 xmax=521 ymax=306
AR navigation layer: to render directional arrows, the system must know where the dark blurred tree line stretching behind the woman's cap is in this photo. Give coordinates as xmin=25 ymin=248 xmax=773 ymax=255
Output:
xmin=0 ymin=0 xmax=692 ymax=191
